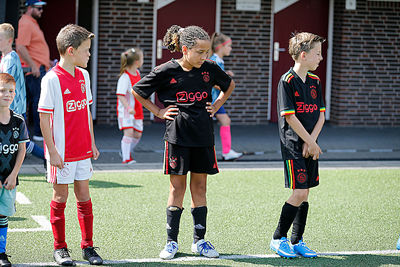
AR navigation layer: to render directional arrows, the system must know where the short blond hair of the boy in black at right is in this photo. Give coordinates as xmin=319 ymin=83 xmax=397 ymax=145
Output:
xmin=289 ymin=32 xmax=325 ymax=60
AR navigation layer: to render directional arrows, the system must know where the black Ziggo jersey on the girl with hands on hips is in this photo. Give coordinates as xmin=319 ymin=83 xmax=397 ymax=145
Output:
xmin=133 ymin=59 xmax=231 ymax=147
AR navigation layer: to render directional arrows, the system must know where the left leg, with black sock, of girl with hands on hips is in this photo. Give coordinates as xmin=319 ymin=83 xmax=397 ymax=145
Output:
xmin=167 ymin=174 xmax=186 ymax=242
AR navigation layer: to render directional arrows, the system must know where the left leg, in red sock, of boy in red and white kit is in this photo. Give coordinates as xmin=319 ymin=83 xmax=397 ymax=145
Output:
xmin=50 ymin=184 xmax=68 ymax=249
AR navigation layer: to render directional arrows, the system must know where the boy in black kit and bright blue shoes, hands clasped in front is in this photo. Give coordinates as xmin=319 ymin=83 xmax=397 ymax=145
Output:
xmin=270 ymin=32 xmax=325 ymax=258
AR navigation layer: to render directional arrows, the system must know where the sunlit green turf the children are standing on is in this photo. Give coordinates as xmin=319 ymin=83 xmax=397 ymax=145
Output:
xmin=7 ymin=169 xmax=400 ymax=266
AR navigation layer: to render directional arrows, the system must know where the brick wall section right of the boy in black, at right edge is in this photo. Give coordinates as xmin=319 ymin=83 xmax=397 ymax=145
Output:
xmin=331 ymin=0 xmax=400 ymax=127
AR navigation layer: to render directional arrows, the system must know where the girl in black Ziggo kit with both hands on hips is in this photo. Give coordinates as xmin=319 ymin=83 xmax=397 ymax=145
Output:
xmin=132 ymin=25 xmax=235 ymax=259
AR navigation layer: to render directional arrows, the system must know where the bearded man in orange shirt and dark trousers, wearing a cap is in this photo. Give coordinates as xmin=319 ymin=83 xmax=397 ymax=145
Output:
xmin=15 ymin=0 xmax=51 ymax=141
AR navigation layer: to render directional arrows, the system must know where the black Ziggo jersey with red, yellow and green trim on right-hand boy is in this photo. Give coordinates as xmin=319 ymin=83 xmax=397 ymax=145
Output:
xmin=278 ymin=68 xmax=325 ymax=160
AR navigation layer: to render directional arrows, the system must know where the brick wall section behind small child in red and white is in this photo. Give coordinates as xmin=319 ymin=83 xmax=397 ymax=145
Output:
xmin=96 ymin=0 xmax=153 ymax=124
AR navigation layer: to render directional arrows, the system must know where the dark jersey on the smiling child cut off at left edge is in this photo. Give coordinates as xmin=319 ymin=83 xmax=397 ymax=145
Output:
xmin=0 ymin=110 xmax=29 ymax=184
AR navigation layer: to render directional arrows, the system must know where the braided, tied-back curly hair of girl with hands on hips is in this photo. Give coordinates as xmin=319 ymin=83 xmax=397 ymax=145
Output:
xmin=163 ymin=25 xmax=210 ymax=53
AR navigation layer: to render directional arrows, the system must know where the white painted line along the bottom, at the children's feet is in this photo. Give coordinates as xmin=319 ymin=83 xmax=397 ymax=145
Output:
xmin=13 ymin=250 xmax=400 ymax=267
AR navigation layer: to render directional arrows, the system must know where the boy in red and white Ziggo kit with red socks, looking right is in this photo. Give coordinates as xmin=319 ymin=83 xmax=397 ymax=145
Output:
xmin=38 ymin=24 xmax=103 ymax=265
